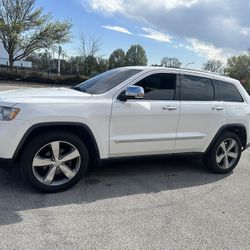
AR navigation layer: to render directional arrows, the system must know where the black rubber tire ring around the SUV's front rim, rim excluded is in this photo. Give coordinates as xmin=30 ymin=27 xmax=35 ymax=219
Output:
xmin=21 ymin=131 xmax=89 ymax=192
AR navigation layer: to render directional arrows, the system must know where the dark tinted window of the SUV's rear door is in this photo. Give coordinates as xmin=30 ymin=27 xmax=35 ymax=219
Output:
xmin=181 ymin=75 xmax=214 ymax=101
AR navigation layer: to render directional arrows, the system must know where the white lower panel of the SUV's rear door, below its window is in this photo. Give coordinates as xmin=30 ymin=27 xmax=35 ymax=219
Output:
xmin=175 ymin=101 xmax=227 ymax=153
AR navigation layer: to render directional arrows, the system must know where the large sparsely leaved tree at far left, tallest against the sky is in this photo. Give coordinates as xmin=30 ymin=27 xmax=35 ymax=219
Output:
xmin=0 ymin=0 xmax=72 ymax=69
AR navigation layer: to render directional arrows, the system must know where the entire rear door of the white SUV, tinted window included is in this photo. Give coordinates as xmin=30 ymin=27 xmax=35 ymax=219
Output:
xmin=175 ymin=74 xmax=227 ymax=153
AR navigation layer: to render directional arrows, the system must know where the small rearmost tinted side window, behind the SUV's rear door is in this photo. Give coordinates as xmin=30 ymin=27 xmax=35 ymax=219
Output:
xmin=214 ymin=80 xmax=244 ymax=102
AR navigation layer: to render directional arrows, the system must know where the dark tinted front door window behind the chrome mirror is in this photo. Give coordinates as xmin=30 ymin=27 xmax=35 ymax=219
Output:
xmin=136 ymin=73 xmax=176 ymax=100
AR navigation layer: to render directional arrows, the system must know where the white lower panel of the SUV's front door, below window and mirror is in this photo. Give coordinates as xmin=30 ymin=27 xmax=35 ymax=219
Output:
xmin=110 ymin=100 xmax=180 ymax=157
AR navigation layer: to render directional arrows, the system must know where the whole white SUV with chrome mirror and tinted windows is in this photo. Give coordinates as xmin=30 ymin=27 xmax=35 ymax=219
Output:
xmin=0 ymin=67 xmax=250 ymax=192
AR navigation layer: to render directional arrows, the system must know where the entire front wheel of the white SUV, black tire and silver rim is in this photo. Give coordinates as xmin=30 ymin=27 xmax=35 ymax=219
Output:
xmin=21 ymin=131 xmax=89 ymax=193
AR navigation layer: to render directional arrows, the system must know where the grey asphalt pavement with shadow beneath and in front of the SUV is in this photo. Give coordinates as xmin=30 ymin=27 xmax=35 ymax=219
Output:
xmin=0 ymin=85 xmax=250 ymax=250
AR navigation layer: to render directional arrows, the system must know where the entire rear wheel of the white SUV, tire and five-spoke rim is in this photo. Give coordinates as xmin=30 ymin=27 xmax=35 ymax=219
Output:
xmin=204 ymin=132 xmax=242 ymax=174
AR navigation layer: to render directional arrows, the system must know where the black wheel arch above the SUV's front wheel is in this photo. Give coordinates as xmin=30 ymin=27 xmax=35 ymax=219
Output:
xmin=13 ymin=122 xmax=100 ymax=164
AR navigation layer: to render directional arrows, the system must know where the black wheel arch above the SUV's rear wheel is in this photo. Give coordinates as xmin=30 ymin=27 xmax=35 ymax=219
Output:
xmin=206 ymin=123 xmax=247 ymax=153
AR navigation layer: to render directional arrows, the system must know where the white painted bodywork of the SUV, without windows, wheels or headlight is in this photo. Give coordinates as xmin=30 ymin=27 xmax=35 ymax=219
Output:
xmin=0 ymin=67 xmax=250 ymax=159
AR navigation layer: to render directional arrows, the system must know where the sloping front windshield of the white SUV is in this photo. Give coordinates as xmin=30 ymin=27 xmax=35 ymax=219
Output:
xmin=73 ymin=68 xmax=141 ymax=95
